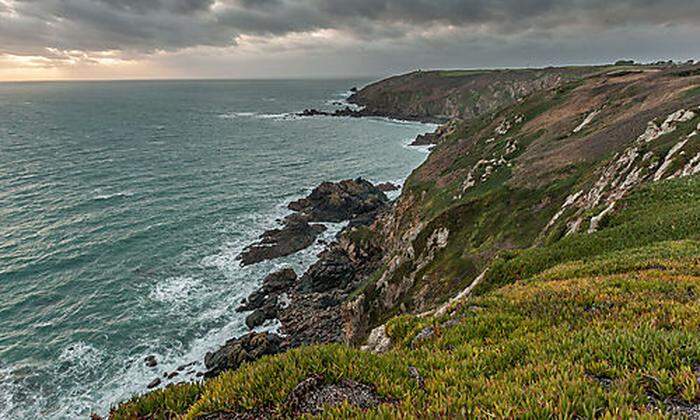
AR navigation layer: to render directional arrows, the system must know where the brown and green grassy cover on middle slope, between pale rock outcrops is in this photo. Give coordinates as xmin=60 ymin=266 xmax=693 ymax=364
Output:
xmin=356 ymin=68 xmax=700 ymax=326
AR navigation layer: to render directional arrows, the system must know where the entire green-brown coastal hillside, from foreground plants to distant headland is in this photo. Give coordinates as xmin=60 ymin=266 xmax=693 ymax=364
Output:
xmin=111 ymin=66 xmax=700 ymax=419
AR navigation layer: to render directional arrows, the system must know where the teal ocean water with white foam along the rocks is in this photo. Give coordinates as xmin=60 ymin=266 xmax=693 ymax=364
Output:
xmin=0 ymin=80 xmax=434 ymax=419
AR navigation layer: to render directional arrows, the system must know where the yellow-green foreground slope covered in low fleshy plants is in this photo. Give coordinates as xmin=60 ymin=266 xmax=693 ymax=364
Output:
xmin=112 ymin=176 xmax=700 ymax=418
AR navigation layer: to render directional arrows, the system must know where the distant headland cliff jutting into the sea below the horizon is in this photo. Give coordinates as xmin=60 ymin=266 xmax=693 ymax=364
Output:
xmin=350 ymin=67 xmax=604 ymax=121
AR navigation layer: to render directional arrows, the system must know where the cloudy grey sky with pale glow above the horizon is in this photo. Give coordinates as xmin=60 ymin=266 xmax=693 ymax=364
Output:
xmin=0 ymin=0 xmax=700 ymax=81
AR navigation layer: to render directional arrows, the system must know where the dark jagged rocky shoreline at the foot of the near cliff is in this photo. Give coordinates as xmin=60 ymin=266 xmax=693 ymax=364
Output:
xmin=204 ymin=178 xmax=398 ymax=377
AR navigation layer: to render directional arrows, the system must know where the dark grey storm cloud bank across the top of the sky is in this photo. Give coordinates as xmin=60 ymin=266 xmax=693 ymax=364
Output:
xmin=0 ymin=0 xmax=700 ymax=54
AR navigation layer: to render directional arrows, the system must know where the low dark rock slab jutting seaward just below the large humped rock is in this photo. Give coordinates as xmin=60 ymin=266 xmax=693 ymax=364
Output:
xmin=238 ymin=215 xmax=326 ymax=265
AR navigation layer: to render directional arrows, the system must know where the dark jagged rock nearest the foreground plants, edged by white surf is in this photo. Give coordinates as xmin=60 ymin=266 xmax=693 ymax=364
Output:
xmin=204 ymin=333 xmax=285 ymax=378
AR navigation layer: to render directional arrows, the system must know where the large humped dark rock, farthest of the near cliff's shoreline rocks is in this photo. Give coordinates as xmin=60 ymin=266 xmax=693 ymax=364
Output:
xmin=288 ymin=178 xmax=389 ymax=222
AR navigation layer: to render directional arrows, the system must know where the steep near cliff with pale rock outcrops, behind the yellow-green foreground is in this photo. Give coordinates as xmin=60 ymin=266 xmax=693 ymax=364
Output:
xmin=345 ymin=65 xmax=700 ymax=343
